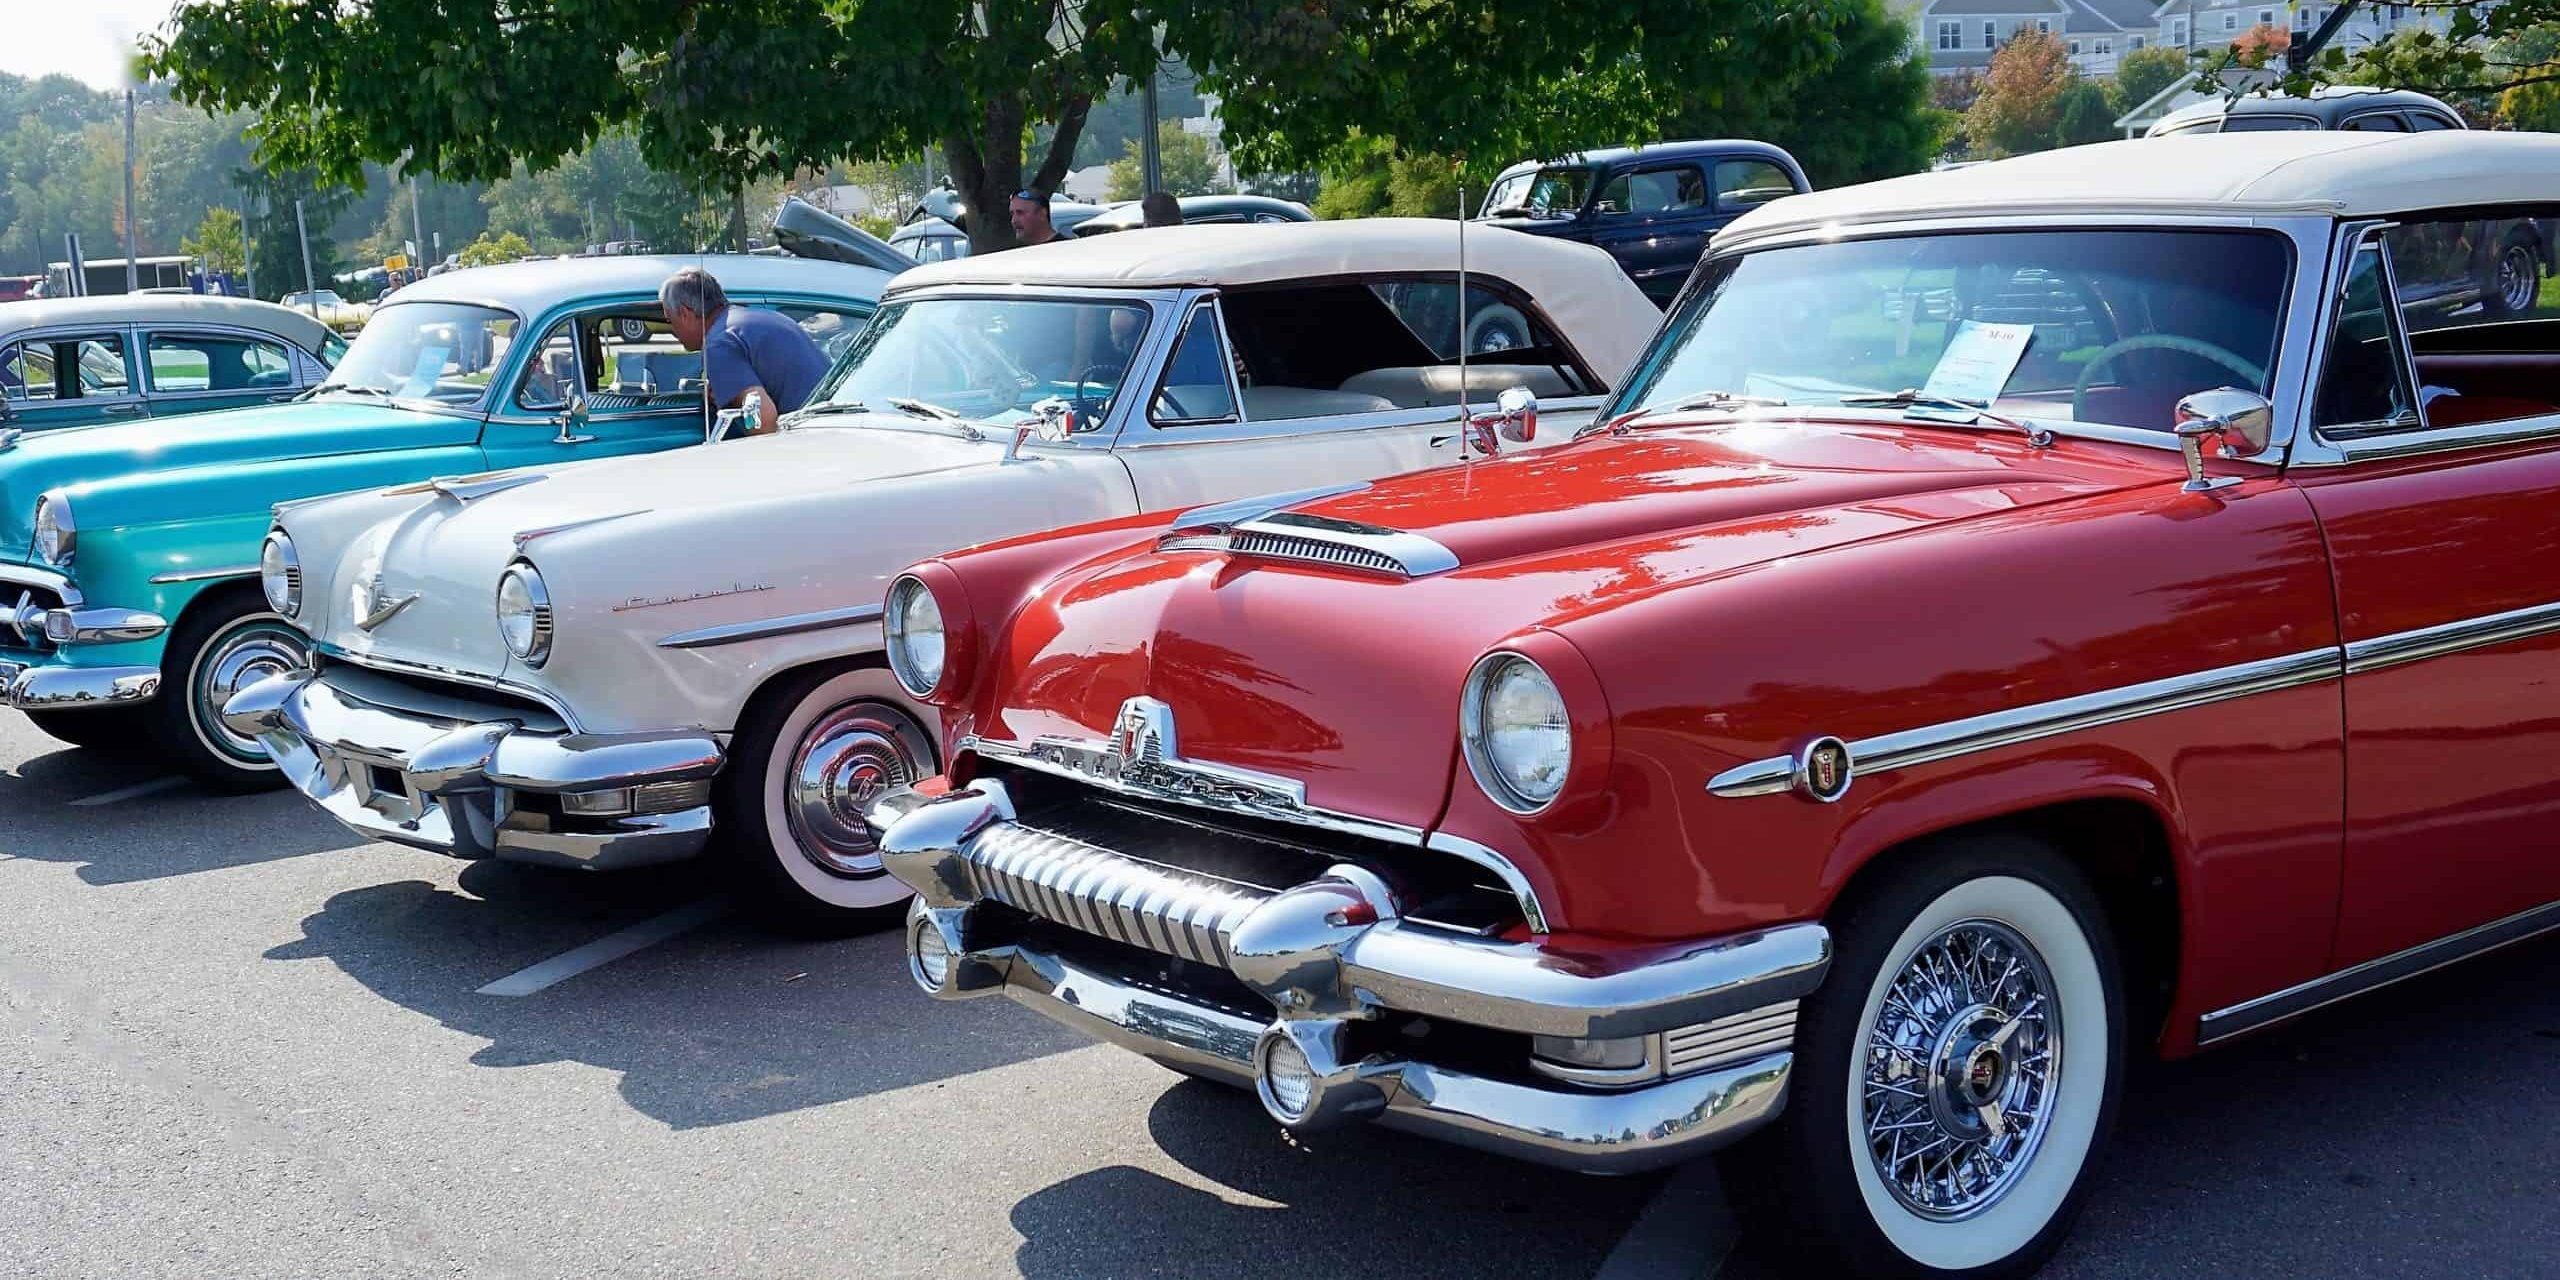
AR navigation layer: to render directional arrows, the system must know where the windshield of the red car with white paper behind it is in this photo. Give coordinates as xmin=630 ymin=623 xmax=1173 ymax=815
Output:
xmin=1615 ymin=230 xmax=2291 ymax=433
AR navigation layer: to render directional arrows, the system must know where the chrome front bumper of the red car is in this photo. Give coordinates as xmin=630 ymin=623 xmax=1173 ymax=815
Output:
xmin=870 ymin=781 xmax=1830 ymax=1172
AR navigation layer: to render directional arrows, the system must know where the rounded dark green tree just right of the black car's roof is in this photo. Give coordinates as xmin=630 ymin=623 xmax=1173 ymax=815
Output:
xmin=1672 ymin=0 xmax=1956 ymax=187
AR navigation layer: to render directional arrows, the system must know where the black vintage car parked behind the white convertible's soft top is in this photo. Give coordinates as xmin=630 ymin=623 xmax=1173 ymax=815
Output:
xmin=1475 ymin=138 xmax=1810 ymax=305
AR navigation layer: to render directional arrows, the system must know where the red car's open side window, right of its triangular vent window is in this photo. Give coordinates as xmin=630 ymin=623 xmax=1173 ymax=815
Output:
xmin=2383 ymin=210 xmax=2560 ymax=428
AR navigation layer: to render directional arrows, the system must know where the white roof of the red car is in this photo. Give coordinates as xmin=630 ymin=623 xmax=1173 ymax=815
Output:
xmin=1715 ymin=131 xmax=2560 ymax=251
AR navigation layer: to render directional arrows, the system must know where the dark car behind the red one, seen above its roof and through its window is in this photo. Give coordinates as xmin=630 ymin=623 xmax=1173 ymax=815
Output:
xmin=2145 ymin=84 xmax=2560 ymax=317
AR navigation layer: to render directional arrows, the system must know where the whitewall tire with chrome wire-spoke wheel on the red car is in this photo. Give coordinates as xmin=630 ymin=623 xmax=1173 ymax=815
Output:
xmin=1736 ymin=837 xmax=2125 ymax=1277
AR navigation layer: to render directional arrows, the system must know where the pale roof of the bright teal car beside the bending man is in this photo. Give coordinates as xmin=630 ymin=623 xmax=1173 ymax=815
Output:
xmin=381 ymin=253 xmax=888 ymax=317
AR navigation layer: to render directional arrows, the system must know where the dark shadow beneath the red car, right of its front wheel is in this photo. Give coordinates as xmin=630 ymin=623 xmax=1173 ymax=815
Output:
xmin=1720 ymin=940 xmax=2560 ymax=1280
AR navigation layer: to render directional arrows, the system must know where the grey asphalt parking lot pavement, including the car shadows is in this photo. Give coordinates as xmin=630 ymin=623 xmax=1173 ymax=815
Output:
xmin=0 ymin=714 xmax=2560 ymax=1280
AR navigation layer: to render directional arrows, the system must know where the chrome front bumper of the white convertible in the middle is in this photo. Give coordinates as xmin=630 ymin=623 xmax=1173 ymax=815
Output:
xmin=223 ymin=671 xmax=722 ymax=870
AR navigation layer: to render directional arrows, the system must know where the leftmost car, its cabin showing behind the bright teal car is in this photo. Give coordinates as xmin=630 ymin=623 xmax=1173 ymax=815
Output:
xmin=0 ymin=294 xmax=346 ymax=438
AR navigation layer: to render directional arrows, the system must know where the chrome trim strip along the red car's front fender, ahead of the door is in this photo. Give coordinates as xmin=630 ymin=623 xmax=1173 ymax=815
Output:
xmin=1708 ymin=648 xmax=2345 ymax=796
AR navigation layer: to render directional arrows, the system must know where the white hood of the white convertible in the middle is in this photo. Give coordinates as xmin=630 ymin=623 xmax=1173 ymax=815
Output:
xmin=325 ymin=428 xmax=1024 ymax=678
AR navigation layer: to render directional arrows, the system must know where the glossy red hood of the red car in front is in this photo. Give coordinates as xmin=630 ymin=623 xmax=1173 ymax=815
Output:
xmin=975 ymin=422 xmax=2181 ymax=827
